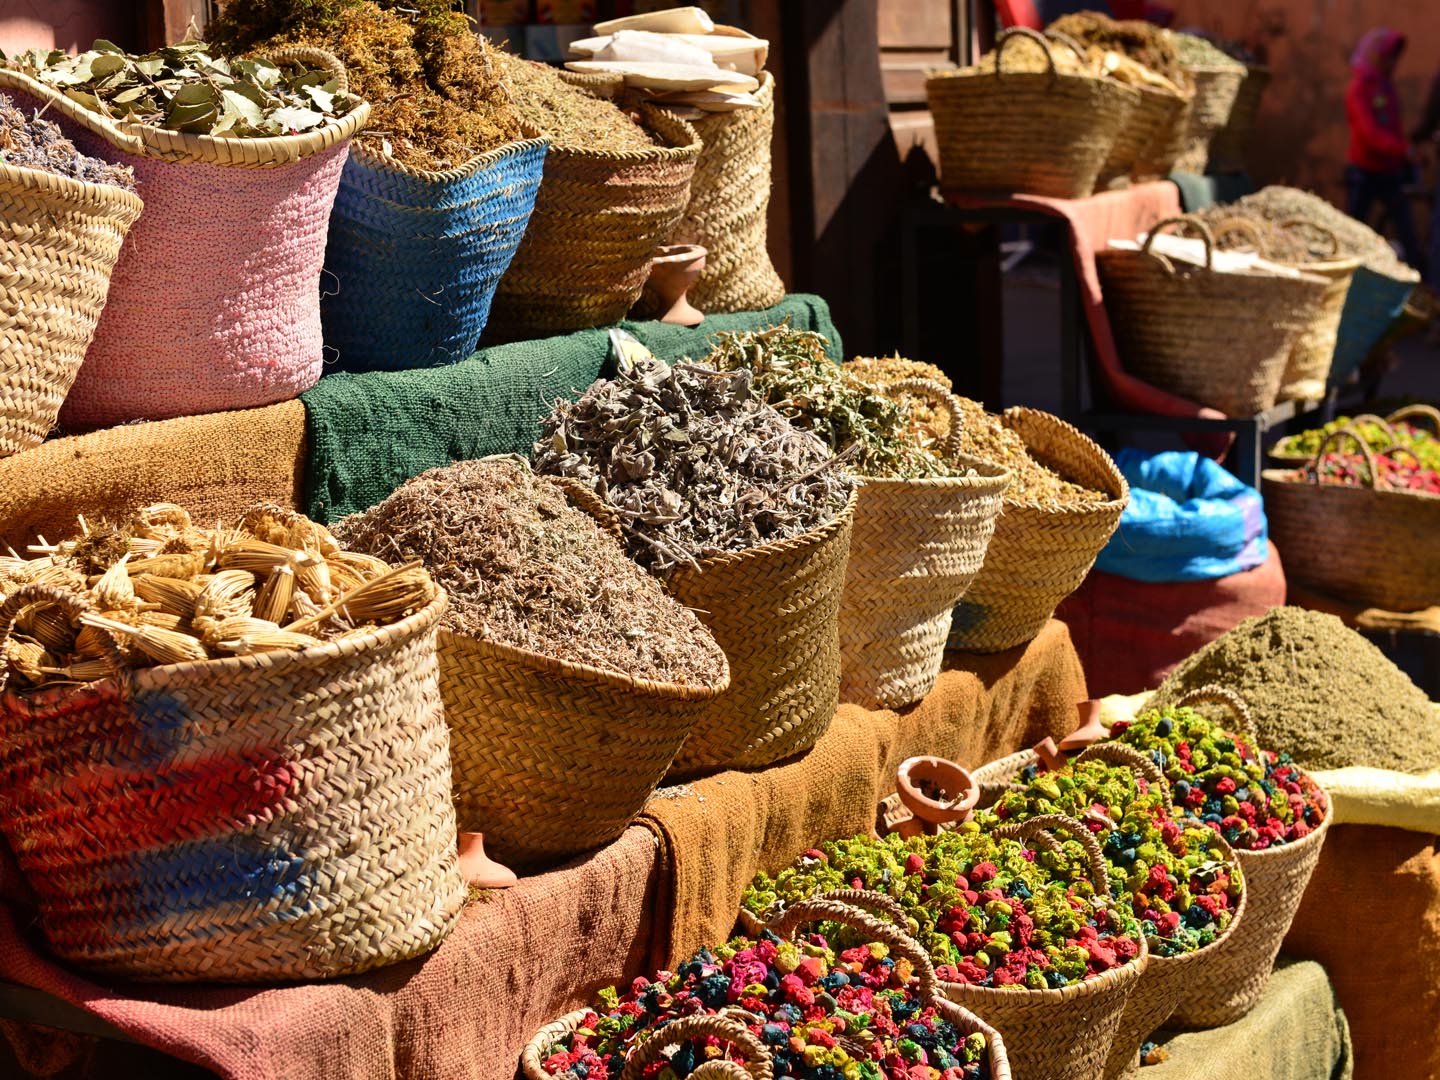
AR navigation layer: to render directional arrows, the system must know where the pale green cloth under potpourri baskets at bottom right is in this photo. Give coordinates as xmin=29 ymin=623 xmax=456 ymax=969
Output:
xmin=1139 ymin=956 xmax=1354 ymax=1080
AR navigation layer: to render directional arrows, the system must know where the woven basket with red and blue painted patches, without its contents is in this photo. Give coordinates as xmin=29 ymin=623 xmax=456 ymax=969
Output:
xmin=0 ymin=586 xmax=465 ymax=982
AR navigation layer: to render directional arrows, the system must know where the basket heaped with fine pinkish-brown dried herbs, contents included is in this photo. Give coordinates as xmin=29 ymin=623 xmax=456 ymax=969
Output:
xmin=336 ymin=456 xmax=729 ymax=870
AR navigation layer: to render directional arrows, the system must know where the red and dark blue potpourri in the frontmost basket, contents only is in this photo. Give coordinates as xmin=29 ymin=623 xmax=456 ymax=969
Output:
xmin=541 ymin=930 xmax=991 ymax=1080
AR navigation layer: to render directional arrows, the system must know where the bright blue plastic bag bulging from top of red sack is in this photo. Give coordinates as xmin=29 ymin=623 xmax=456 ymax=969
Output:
xmin=1094 ymin=448 xmax=1269 ymax=582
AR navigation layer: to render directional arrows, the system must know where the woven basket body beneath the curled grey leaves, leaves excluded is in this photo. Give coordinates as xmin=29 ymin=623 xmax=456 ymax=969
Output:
xmin=665 ymin=495 xmax=857 ymax=778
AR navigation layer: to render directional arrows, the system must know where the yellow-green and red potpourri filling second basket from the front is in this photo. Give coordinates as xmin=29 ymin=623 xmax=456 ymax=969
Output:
xmin=740 ymin=822 xmax=1140 ymax=989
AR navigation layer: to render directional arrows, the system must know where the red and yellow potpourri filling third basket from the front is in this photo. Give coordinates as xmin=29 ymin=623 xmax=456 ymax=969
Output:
xmin=979 ymin=760 xmax=1243 ymax=956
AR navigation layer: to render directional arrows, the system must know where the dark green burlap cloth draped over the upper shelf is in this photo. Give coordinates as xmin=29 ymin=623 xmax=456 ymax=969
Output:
xmin=301 ymin=294 xmax=844 ymax=521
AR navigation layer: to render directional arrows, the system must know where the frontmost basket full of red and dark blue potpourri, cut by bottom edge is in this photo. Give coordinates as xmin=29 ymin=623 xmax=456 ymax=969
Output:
xmin=520 ymin=900 xmax=1011 ymax=1080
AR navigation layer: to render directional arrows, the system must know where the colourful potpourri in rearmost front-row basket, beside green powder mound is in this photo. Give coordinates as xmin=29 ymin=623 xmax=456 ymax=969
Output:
xmin=1110 ymin=707 xmax=1326 ymax=851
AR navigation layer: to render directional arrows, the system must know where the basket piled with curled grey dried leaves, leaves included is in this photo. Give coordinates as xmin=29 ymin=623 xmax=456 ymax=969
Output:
xmin=534 ymin=357 xmax=855 ymax=775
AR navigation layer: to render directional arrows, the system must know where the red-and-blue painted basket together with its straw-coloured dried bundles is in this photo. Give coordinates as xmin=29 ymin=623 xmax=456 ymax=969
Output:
xmin=0 ymin=505 xmax=465 ymax=982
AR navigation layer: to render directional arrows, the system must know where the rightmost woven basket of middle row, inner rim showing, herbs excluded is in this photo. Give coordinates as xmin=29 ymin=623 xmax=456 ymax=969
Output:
xmin=949 ymin=406 xmax=1130 ymax=652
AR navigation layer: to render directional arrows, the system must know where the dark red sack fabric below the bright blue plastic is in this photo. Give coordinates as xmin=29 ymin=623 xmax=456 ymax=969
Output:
xmin=1056 ymin=543 xmax=1284 ymax=697
